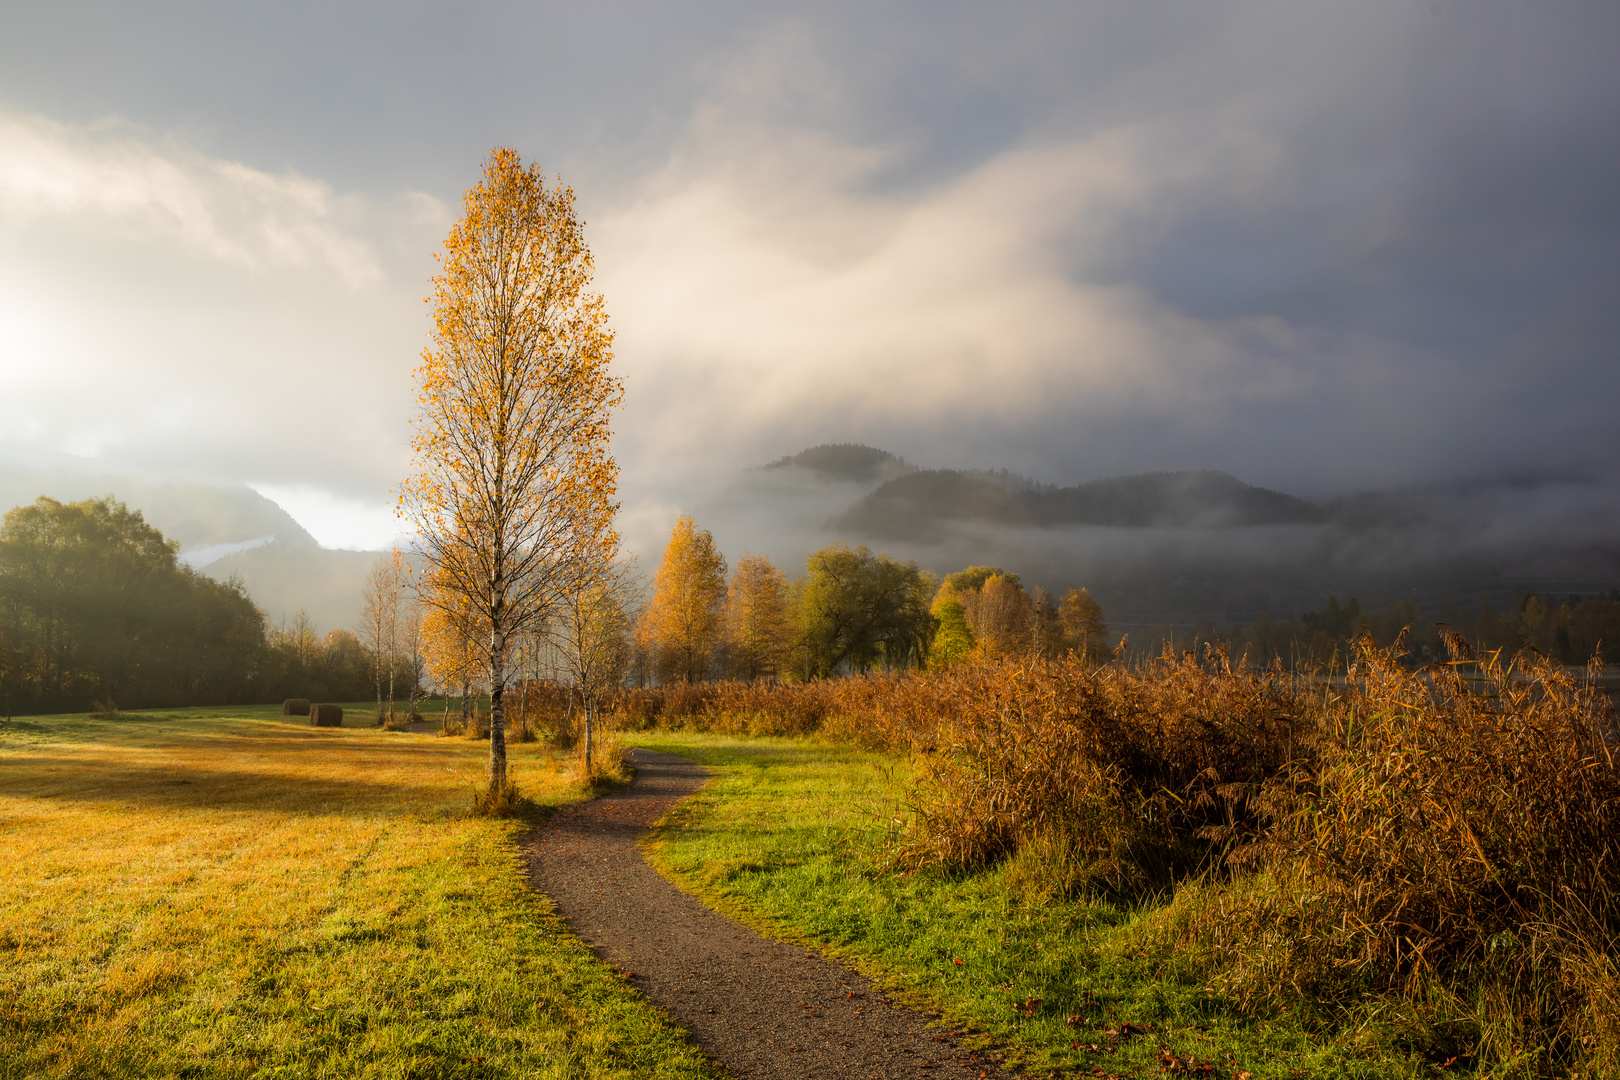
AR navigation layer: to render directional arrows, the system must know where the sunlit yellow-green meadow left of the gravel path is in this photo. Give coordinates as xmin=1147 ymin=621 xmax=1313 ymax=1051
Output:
xmin=0 ymin=708 xmax=710 ymax=1078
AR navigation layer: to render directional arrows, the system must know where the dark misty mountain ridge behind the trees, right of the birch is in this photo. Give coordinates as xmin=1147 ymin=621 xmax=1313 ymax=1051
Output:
xmin=699 ymin=444 xmax=1620 ymax=633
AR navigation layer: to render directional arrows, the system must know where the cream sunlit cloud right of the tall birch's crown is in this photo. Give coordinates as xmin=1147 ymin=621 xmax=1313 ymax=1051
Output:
xmin=593 ymin=98 xmax=1443 ymax=497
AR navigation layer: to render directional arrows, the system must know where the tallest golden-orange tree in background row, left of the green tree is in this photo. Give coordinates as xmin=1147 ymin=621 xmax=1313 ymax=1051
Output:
xmin=637 ymin=517 xmax=726 ymax=683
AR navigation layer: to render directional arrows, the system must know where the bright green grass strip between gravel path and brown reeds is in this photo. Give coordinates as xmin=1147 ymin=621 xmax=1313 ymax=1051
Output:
xmin=632 ymin=732 xmax=1439 ymax=1080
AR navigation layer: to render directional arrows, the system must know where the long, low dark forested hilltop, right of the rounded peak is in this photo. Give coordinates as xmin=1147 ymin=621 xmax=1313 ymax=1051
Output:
xmin=833 ymin=470 xmax=1327 ymax=541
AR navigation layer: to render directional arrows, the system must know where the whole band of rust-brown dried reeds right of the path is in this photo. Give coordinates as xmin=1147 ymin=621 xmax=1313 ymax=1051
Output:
xmin=614 ymin=635 xmax=1620 ymax=1075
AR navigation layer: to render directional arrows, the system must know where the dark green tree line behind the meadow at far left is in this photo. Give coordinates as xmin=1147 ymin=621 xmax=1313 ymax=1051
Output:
xmin=0 ymin=495 xmax=423 ymax=716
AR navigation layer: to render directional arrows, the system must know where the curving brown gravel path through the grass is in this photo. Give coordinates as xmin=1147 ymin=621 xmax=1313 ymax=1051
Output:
xmin=528 ymin=750 xmax=1004 ymax=1080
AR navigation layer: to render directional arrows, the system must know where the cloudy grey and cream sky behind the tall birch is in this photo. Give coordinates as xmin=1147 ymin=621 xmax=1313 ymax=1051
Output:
xmin=0 ymin=0 xmax=1620 ymax=557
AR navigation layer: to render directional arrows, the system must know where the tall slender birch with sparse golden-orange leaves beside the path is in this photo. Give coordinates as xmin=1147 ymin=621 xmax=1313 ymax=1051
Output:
xmin=400 ymin=147 xmax=624 ymax=798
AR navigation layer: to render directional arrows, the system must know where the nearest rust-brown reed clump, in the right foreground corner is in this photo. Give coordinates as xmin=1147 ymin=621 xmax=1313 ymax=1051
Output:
xmin=1173 ymin=635 xmax=1620 ymax=1075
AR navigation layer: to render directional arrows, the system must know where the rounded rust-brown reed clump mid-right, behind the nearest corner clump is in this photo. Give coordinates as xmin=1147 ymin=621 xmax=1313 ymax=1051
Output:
xmin=894 ymin=648 xmax=1309 ymax=892
